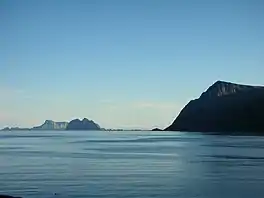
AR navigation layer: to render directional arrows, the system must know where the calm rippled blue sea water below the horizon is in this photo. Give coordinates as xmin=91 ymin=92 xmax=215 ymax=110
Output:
xmin=0 ymin=131 xmax=264 ymax=198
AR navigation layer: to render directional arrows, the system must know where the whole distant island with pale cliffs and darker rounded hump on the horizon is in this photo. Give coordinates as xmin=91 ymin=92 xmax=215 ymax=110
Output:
xmin=2 ymin=118 xmax=101 ymax=131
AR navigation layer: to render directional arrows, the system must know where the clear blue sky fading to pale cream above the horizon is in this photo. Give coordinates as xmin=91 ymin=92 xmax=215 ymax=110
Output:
xmin=0 ymin=0 xmax=264 ymax=129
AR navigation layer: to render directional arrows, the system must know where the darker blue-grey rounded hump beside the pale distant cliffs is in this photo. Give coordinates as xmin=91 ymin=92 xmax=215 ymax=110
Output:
xmin=66 ymin=118 xmax=101 ymax=130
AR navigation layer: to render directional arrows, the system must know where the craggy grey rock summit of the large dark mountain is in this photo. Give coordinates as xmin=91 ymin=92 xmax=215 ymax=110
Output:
xmin=201 ymin=80 xmax=254 ymax=98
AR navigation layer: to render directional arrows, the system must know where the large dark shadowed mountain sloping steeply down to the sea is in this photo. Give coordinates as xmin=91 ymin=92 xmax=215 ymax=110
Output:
xmin=165 ymin=81 xmax=264 ymax=133
